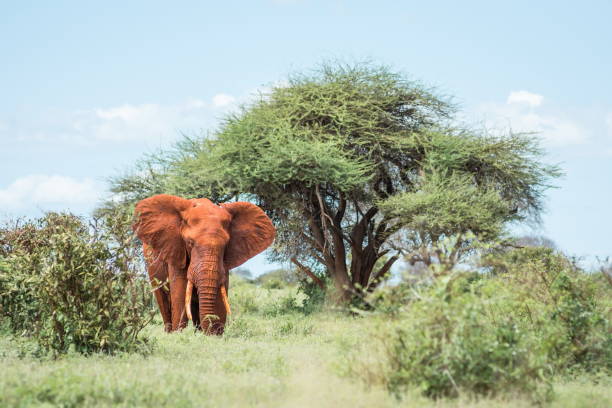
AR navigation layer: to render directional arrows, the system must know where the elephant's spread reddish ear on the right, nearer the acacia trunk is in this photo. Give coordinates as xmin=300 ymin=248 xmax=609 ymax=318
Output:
xmin=221 ymin=202 xmax=276 ymax=270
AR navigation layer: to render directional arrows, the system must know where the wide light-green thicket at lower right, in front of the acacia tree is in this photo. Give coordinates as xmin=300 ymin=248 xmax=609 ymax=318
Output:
xmin=351 ymin=247 xmax=612 ymax=400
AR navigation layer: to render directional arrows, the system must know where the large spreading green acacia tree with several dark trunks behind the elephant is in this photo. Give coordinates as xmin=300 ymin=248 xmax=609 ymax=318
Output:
xmin=113 ymin=64 xmax=558 ymax=299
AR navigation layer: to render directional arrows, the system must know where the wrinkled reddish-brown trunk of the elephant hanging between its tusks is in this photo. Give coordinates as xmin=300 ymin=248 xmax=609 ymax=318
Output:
xmin=193 ymin=248 xmax=226 ymax=334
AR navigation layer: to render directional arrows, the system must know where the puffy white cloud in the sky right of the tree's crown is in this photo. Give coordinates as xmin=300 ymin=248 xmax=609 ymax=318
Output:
xmin=475 ymin=91 xmax=589 ymax=147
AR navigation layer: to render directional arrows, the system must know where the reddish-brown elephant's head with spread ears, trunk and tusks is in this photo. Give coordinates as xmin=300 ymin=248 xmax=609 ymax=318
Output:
xmin=134 ymin=194 xmax=276 ymax=332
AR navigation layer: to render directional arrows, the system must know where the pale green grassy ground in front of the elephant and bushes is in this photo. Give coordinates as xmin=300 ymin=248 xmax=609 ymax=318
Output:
xmin=0 ymin=285 xmax=612 ymax=408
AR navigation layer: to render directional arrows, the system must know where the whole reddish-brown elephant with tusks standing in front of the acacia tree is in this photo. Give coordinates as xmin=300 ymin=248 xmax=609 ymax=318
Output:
xmin=133 ymin=194 xmax=276 ymax=334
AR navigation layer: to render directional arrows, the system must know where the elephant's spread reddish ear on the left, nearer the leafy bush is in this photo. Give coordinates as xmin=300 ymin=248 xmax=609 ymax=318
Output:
xmin=132 ymin=194 xmax=191 ymax=268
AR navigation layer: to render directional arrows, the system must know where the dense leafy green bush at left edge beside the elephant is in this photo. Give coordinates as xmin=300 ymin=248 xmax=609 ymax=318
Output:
xmin=0 ymin=213 xmax=154 ymax=355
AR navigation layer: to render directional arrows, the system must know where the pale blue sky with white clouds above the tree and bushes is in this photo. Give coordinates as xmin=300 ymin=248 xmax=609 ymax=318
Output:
xmin=0 ymin=0 xmax=612 ymax=274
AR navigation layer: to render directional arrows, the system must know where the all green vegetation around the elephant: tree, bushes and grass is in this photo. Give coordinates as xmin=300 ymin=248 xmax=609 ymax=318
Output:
xmin=0 ymin=65 xmax=612 ymax=407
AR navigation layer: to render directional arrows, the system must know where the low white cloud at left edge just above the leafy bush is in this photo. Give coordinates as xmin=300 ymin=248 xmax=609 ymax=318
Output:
xmin=0 ymin=174 xmax=102 ymax=210
